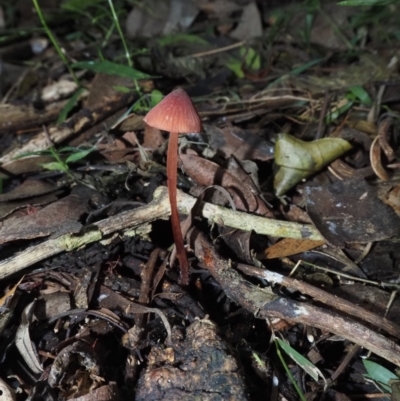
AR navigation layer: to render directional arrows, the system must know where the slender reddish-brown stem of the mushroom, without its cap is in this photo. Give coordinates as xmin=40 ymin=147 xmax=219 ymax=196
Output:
xmin=167 ymin=132 xmax=189 ymax=285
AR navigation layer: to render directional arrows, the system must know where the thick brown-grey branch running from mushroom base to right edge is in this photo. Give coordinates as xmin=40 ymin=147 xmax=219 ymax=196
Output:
xmin=191 ymin=230 xmax=400 ymax=366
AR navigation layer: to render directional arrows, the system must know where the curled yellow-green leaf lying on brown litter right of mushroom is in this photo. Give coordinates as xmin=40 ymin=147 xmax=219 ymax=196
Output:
xmin=274 ymin=134 xmax=352 ymax=196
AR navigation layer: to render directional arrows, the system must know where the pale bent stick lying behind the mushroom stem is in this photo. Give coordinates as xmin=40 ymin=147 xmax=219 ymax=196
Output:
xmin=0 ymin=187 xmax=322 ymax=279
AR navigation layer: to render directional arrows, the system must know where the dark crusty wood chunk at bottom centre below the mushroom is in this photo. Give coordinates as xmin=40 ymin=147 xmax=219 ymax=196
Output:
xmin=135 ymin=319 xmax=249 ymax=401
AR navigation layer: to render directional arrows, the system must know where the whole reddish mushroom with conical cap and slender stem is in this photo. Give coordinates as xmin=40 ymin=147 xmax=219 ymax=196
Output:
xmin=143 ymin=89 xmax=202 ymax=285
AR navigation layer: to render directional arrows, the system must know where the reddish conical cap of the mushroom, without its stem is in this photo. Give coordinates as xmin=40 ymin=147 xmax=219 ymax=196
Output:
xmin=143 ymin=89 xmax=202 ymax=134
